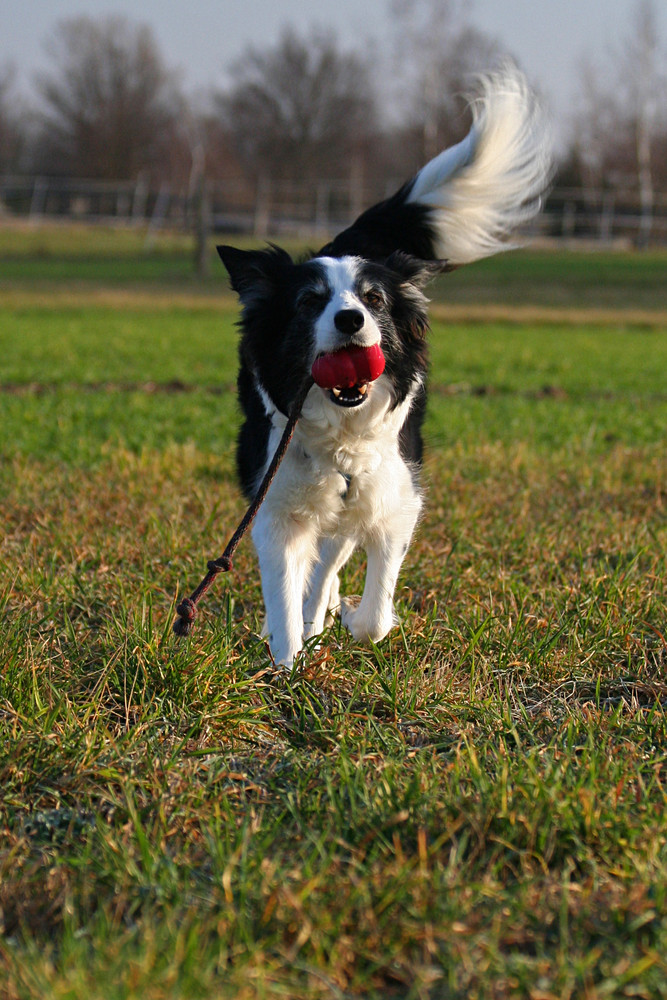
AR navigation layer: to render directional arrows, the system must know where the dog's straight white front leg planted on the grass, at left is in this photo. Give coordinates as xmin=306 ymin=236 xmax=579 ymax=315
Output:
xmin=252 ymin=510 xmax=315 ymax=667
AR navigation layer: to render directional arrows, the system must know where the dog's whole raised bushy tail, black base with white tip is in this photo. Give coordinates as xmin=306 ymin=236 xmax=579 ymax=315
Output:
xmin=321 ymin=63 xmax=553 ymax=266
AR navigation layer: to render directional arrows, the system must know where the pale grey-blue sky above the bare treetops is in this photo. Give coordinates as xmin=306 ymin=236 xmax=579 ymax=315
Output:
xmin=0 ymin=0 xmax=667 ymax=146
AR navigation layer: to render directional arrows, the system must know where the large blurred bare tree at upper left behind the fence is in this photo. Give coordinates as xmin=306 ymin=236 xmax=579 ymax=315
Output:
xmin=37 ymin=17 xmax=182 ymax=179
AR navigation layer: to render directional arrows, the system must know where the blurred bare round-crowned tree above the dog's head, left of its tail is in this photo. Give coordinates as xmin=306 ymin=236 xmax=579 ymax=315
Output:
xmin=216 ymin=29 xmax=376 ymax=186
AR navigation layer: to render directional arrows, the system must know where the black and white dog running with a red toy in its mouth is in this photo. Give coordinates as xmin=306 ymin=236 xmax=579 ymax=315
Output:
xmin=218 ymin=66 xmax=551 ymax=666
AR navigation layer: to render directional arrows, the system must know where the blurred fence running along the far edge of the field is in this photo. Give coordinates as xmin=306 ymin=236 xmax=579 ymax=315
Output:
xmin=0 ymin=176 xmax=667 ymax=246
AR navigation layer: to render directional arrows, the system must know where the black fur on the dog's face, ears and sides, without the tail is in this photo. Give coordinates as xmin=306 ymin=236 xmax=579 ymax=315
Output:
xmin=218 ymin=246 xmax=442 ymax=498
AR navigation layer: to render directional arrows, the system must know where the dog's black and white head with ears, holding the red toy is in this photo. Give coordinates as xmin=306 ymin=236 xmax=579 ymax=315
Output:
xmin=218 ymin=246 xmax=445 ymax=413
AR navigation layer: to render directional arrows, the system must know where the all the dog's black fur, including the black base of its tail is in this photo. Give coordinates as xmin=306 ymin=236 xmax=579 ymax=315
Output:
xmin=218 ymin=181 xmax=447 ymax=498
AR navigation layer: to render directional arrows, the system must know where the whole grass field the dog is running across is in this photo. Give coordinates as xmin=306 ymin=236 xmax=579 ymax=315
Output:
xmin=0 ymin=228 xmax=667 ymax=1000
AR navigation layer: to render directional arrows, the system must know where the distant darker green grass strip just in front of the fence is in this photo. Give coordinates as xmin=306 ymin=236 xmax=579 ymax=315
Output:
xmin=0 ymin=224 xmax=667 ymax=310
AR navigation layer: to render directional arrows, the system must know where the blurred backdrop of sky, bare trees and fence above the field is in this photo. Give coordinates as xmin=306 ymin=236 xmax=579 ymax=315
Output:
xmin=0 ymin=0 xmax=667 ymax=258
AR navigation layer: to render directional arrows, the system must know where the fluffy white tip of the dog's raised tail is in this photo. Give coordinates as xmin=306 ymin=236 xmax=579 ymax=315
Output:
xmin=408 ymin=63 xmax=552 ymax=264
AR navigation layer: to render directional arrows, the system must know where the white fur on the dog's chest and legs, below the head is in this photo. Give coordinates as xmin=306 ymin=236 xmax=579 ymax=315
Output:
xmin=252 ymin=358 xmax=422 ymax=666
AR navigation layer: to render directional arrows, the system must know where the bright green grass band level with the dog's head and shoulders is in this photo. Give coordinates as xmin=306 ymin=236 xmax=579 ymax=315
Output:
xmin=0 ymin=301 xmax=667 ymax=464
